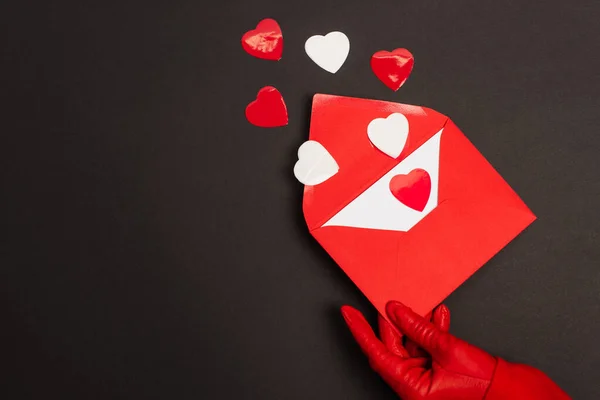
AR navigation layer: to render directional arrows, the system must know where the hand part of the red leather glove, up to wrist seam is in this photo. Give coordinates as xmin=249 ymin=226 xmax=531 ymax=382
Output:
xmin=342 ymin=302 xmax=497 ymax=400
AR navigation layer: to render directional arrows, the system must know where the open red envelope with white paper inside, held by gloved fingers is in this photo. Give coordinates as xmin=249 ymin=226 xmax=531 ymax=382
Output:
xmin=303 ymin=94 xmax=536 ymax=315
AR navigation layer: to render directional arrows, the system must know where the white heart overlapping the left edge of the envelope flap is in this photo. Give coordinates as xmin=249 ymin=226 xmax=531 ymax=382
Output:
xmin=294 ymin=140 xmax=340 ymax=185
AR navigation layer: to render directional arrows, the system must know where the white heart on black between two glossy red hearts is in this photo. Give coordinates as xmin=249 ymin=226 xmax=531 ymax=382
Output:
xmin=304 ymin=32 xmax=350 ymax=74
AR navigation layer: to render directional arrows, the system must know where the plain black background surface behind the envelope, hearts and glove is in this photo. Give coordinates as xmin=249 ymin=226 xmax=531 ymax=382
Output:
xmin=0 ymin=0 xmax=600 ymax=399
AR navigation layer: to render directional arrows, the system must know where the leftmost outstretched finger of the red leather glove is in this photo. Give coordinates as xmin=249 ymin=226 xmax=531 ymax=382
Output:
xmin=342 ymin=306 xmax=391 ymax=364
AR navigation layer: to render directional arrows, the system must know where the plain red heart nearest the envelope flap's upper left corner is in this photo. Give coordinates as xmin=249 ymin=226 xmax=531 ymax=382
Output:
xmin=246 ymin=86 xmax=288 ymax=128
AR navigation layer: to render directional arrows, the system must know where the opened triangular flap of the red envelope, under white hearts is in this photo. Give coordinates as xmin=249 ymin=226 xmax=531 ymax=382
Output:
xmin=303 ymin=94 xmax=448 ymax=230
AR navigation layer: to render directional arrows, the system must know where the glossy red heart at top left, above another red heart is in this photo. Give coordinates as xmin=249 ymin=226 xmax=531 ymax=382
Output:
xmin=242 ymin=18 xmax=283 ymax=61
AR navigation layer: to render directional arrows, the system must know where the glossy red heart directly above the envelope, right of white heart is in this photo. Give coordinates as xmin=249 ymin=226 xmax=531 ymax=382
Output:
xmin=371 ymin=49 xmax=415 ymax=91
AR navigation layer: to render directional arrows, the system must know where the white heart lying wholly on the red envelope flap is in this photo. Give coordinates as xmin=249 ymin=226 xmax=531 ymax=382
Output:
xmin=367 ymin=113 xmax=408 ymax=158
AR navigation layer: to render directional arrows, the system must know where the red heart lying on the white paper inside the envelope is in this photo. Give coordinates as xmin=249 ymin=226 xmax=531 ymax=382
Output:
xmin=390 ymin=168 xmax=431 ymax=211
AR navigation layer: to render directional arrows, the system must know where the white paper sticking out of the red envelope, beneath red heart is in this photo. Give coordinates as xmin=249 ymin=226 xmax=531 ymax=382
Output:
xmin=323 ymin=129 xmax=443 ymax=232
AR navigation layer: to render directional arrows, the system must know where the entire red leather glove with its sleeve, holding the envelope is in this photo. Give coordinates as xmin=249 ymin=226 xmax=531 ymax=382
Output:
xmin=342 ymin=302 xmax=570 ymax=400
